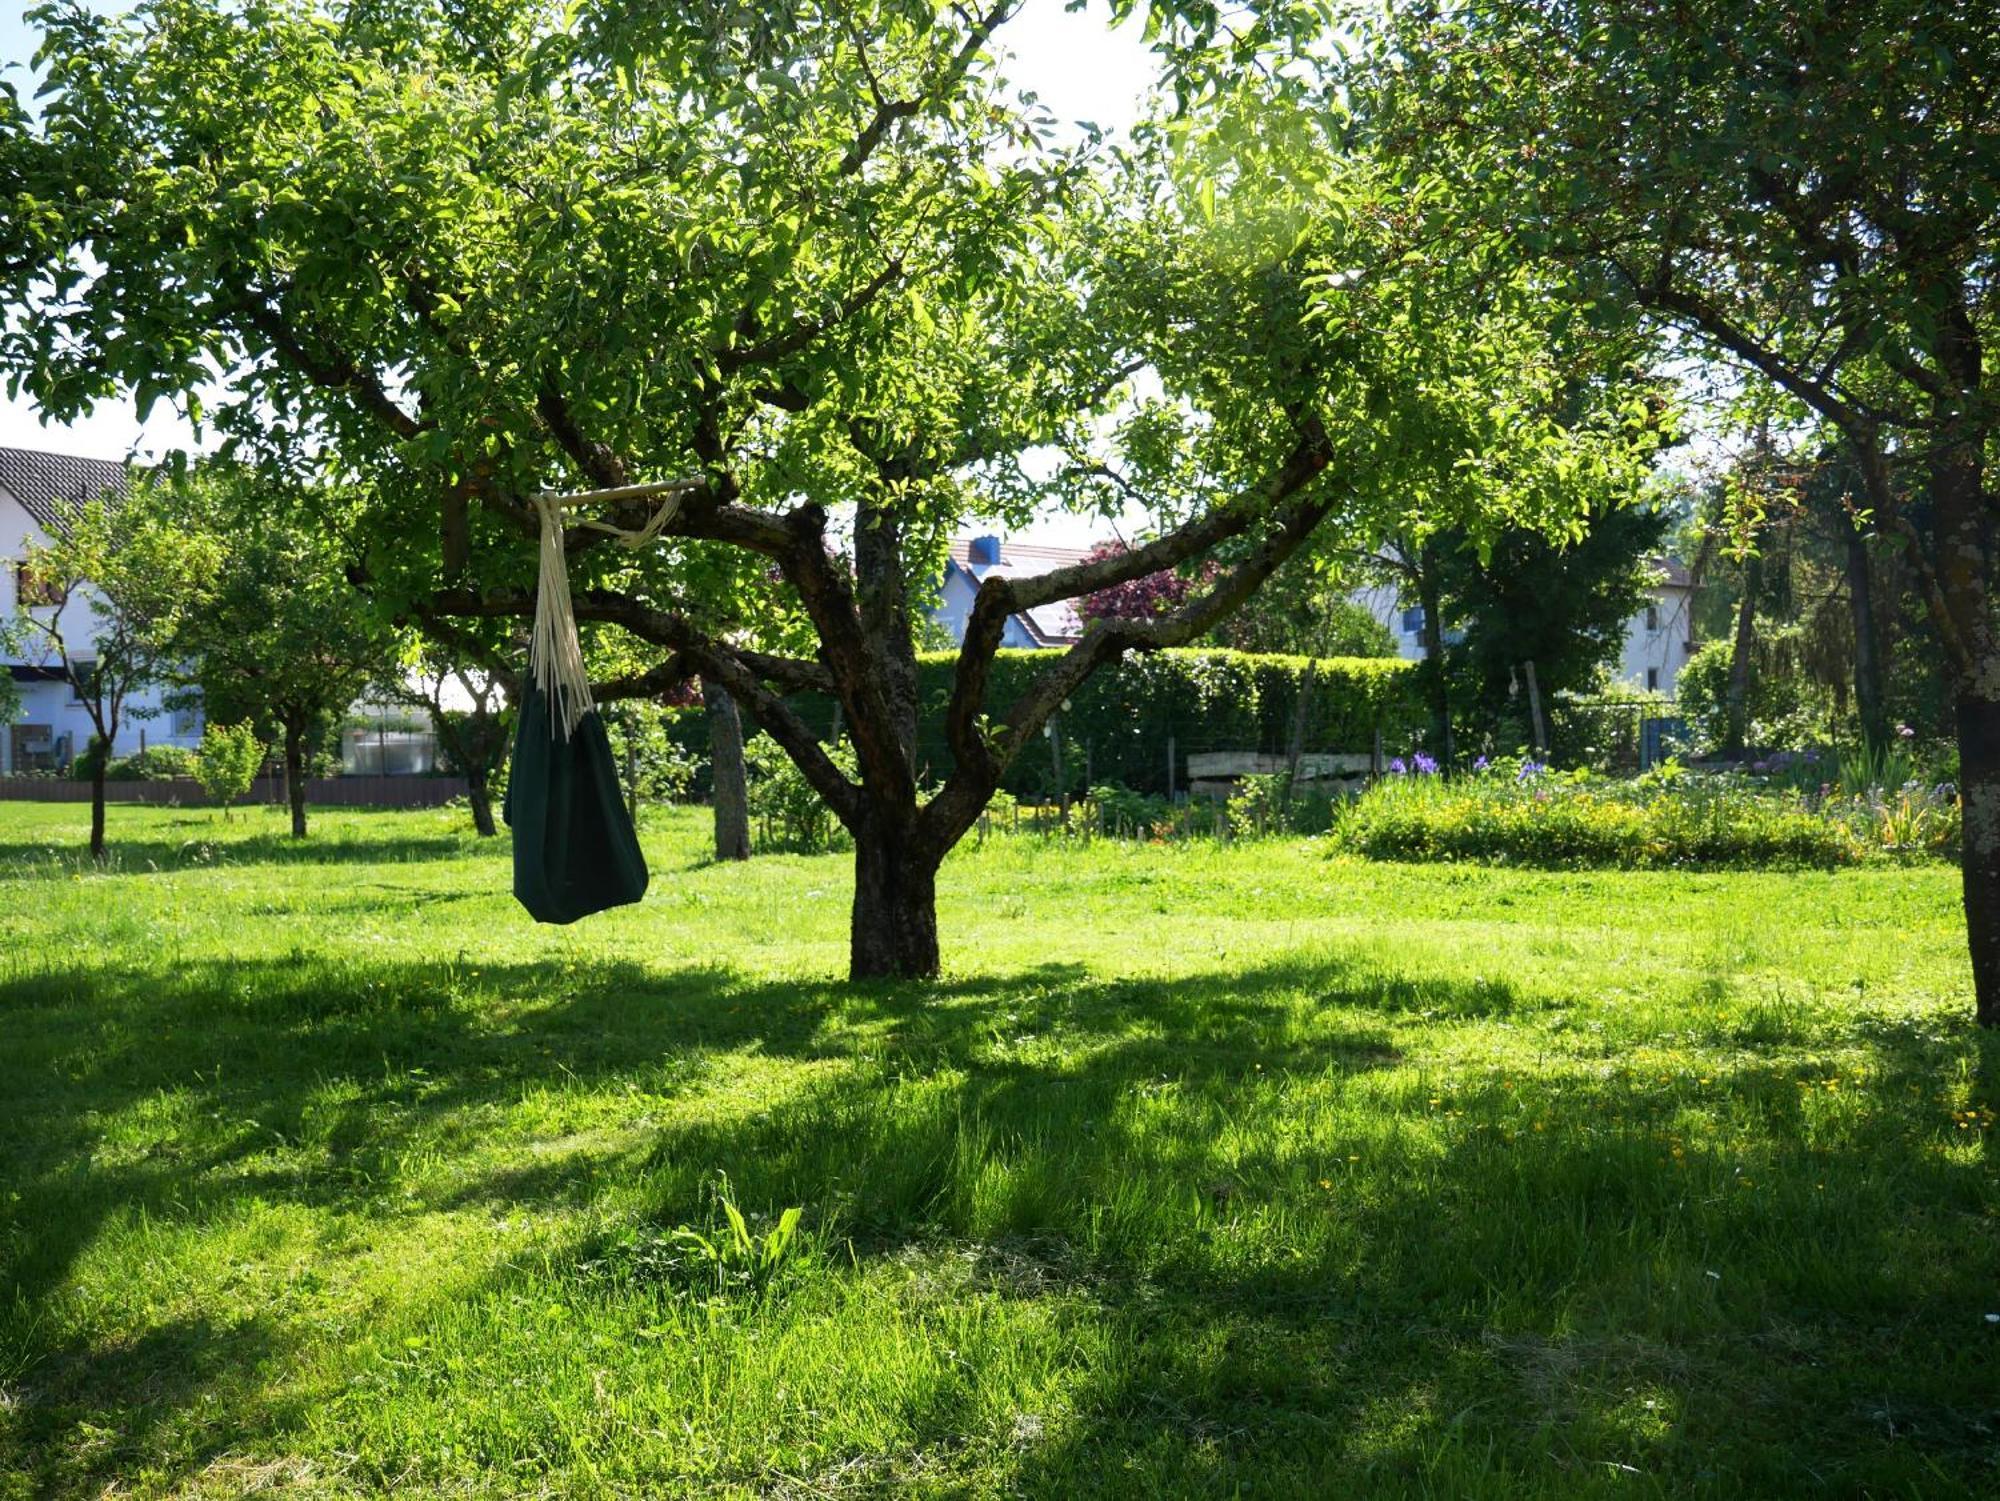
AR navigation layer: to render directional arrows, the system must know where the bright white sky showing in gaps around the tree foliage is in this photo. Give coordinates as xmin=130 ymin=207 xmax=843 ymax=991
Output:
xmin=0 ymin=0 xmax=1154 ymax=546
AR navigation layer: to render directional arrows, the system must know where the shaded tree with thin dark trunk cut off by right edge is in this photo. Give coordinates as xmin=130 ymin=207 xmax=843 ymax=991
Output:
xmin=1366 ymin=0 xmax=2000 ymax=1025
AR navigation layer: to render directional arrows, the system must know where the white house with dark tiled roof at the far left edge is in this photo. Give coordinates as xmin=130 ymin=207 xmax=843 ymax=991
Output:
xmin=0 ymin=448 xmax=202 ymax=775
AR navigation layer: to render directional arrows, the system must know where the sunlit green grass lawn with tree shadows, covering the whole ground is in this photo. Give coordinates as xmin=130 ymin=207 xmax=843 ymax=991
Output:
xmin=0 ymin=805 xmax=2000 ymax=1501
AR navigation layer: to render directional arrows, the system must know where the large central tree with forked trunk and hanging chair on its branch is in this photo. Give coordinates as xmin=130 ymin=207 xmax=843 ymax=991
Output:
xmin=6 ymin=0 xmax=1664 ymax=977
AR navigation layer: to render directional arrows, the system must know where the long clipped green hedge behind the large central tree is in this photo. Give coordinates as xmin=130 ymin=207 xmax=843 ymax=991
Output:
xmin=692 ymin=646 xmax=1424 ymax=797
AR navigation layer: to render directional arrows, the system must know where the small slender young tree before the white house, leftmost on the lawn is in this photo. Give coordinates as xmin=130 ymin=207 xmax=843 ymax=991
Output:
xmin=14 ymin=494 xmax=212 ymax=861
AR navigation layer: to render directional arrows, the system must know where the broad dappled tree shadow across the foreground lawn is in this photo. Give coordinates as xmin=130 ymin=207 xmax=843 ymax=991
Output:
xmin=0 ymin=957 xmax=2000 ymax=1495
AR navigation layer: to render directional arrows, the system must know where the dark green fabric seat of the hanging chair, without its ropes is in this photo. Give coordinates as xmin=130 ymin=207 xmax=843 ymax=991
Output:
xmin=504 ymin=686 xmax=646 ymax=923
